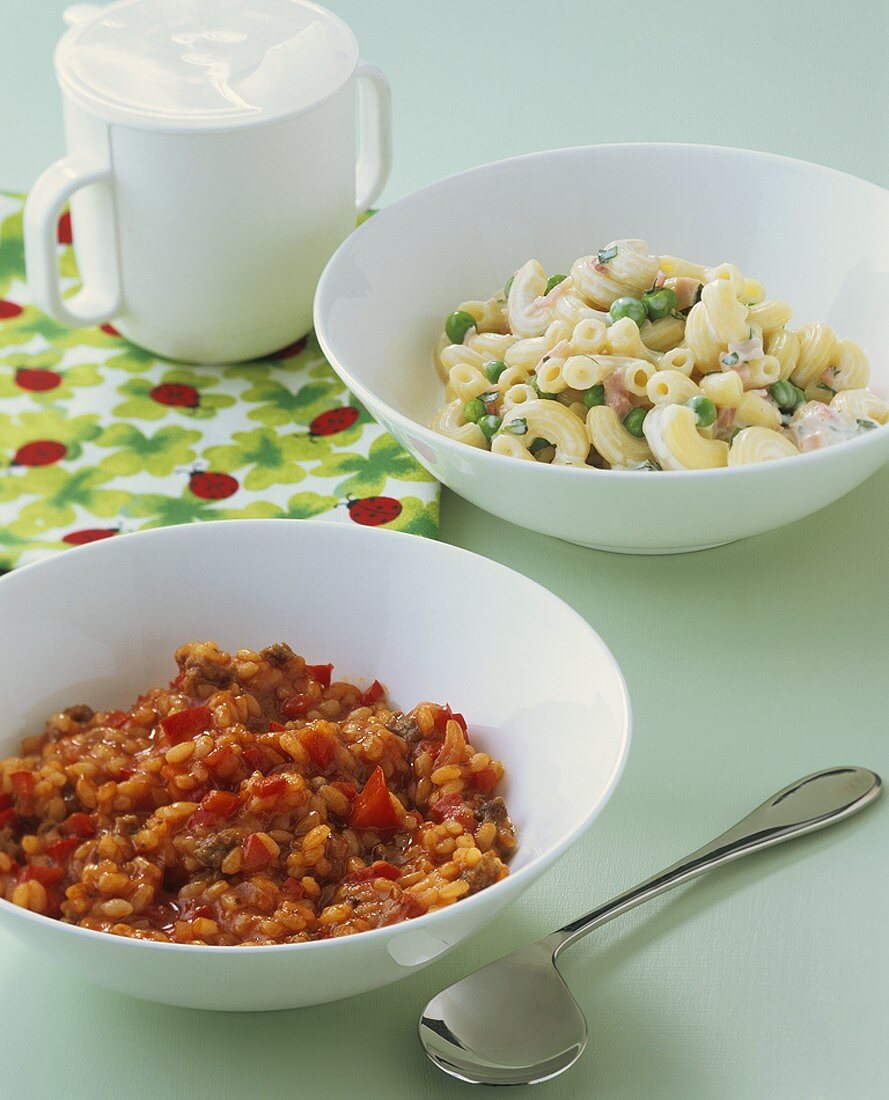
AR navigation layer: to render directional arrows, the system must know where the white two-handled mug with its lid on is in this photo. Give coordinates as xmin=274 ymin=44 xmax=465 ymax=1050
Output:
xmin=24 ymin=0 xmax=392 ymax=363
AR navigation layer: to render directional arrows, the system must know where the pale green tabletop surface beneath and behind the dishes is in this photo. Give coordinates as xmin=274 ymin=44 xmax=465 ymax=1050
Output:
xmin=0 ymin=0 xmax=889 ymax=1100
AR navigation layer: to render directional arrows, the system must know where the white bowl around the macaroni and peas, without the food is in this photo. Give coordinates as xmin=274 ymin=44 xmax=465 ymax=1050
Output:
xmin=315 ymin=144 xmax=889 ymax=553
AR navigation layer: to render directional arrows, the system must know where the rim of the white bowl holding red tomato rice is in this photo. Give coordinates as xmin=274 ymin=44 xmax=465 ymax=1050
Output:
xmin=0 ymin=519 xmax=633 ymax=950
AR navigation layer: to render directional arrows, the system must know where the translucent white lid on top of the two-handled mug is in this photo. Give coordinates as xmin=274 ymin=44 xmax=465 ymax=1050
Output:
xmin=55 ymin=0 xmax=359 ymax=130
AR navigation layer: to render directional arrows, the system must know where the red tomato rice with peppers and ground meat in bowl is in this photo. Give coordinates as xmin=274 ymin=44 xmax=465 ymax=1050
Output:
xmin=0 ymin=641 xmax=516 ymax=946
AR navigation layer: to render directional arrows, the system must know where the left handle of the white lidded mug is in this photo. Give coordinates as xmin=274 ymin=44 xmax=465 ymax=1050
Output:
xmin=24 ymin=155 xmax=121 ymax=327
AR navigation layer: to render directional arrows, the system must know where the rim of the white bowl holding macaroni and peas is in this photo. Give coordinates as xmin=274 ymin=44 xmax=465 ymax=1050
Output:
xmin=312 ymin=141 xmax=889 ymax=482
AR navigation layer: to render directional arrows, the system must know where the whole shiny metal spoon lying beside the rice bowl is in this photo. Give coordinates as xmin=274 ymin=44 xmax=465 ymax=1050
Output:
xmin=419 ymin=768 xmax=880 ymax=1085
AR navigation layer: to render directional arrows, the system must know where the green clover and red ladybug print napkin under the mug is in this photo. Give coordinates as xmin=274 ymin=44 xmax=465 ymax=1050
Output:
xmin=0 ymin=193 xmax=439 ymax=572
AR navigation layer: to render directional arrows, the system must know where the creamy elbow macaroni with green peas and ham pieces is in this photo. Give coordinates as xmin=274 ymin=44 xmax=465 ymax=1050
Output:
xmin=432 ymin=240 xmax=889 ymax=471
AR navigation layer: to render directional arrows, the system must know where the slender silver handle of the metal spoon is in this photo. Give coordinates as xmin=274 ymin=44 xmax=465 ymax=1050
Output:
xmin=547 ymin=767 xmax=880 ymax=954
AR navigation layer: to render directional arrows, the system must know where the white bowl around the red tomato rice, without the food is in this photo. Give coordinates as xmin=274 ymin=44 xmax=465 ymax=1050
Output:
xmin=0 ymin=520 xmax=629 ymax=1010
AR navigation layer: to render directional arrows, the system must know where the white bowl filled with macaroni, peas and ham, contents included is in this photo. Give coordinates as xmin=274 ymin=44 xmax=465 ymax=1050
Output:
xmin=315 ymin=144 xmax=889 ymax=553
